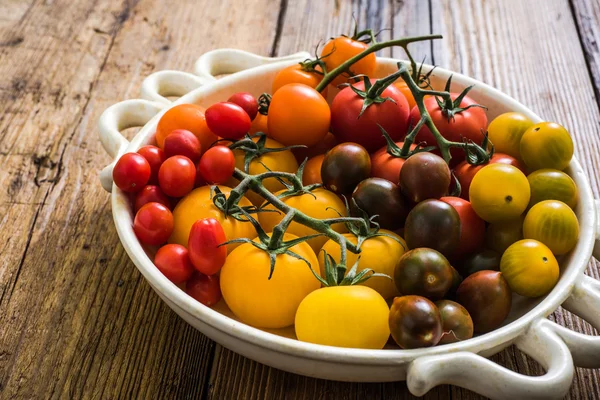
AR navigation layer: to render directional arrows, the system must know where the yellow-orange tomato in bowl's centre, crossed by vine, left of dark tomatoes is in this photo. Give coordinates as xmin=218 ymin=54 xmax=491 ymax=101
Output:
xmin=258 ymin=188 xmax=348 ymax=253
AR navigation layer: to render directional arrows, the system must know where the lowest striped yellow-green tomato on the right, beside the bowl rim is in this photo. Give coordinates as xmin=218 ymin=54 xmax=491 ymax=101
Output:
xmin=500 ymin=239 xmax=559 ymax=297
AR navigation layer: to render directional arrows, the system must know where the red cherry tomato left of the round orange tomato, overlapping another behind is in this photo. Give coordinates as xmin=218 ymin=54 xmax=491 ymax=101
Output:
xmin=205 ymin=102 xmax=252 ymax=140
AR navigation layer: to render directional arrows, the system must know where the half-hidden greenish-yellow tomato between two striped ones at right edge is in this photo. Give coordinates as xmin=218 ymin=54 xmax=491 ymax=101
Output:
xmin=527 ymin=169 xmax=579 ymax=208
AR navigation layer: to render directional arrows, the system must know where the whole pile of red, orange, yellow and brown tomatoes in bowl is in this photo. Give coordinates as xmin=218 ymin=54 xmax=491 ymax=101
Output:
xmin=113 ymin=32 xmax=579 ymax=349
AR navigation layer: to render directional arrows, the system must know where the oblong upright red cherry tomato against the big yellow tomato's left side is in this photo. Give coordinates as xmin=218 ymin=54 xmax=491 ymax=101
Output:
xmin=188 ymin=218 xmax=227 ymax=275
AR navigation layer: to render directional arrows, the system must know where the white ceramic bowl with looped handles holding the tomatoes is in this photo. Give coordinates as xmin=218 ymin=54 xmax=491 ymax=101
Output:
xmin=99 ymin=49 xmax=600 ymax=399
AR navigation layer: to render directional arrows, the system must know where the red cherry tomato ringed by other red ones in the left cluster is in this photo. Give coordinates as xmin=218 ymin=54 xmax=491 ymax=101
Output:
xmin=158 ymin=156 xmax=196 ymax=197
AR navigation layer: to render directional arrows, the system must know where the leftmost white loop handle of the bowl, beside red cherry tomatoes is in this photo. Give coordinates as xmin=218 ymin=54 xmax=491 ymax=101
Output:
xmin=98 ymin=99 xmax=164 ymax=192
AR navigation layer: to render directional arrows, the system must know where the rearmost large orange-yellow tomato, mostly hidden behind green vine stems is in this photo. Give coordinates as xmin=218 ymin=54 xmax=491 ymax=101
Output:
xmin=227 ymin=138 xmax=298 ymax=207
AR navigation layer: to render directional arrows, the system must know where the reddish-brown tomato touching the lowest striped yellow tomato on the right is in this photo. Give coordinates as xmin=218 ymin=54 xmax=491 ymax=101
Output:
xmin=456 ymin=271 xmax=512 ymax=333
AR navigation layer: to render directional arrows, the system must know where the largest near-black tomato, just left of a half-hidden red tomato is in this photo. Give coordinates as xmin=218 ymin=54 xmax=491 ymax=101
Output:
xmin=404 ymin=200 xmax=460 ymax=258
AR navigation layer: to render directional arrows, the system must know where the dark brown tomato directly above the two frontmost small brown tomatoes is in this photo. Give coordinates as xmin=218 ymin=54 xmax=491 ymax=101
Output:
xmin=394 ymin=248 xmax=454 ymax=300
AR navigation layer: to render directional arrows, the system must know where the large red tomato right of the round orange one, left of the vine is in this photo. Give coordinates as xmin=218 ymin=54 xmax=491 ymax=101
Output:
xmin=331 ymin=82 xmax=410 ymax=153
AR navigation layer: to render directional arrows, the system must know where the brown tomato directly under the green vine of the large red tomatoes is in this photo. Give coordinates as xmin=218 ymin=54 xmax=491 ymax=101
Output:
xmin=399 ymin=152 xmax=450 ymax=203
